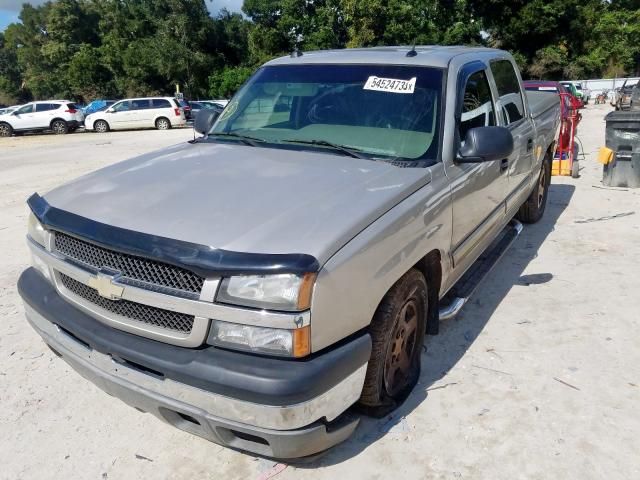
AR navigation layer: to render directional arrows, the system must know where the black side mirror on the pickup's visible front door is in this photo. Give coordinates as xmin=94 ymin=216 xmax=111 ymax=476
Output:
xmin=456 ymin=127 xmax=513 ymax=163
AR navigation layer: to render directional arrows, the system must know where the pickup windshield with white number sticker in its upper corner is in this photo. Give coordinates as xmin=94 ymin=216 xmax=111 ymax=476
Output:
xmin=210 ymin=65 xmax=442 ymax=160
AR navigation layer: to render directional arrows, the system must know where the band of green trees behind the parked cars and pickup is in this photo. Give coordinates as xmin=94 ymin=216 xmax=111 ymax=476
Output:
xmin=0 ymin=0 xmax=640 ymax=103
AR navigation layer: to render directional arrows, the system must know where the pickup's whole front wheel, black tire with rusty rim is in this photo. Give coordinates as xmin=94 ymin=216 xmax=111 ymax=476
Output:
xmin=359 ymin=269 xmax=428 ymax=417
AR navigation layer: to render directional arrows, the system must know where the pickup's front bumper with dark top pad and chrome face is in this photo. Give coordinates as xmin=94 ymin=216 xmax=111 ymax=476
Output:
xmin=18 ymin=269 xmax=371 ymax=459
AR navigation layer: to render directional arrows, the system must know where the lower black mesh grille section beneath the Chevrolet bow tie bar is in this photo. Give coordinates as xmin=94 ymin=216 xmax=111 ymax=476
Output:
xmin=59 ymin=273 xmax=194 ymax=334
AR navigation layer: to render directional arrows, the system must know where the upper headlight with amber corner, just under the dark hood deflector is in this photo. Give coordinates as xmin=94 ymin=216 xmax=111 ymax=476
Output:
xmin=216 ymin=273 xmax=316 ymax=312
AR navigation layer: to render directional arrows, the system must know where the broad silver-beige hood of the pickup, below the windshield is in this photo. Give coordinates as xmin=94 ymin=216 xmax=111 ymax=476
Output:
xmin=45 ymin=143 xmax=431 ymax=265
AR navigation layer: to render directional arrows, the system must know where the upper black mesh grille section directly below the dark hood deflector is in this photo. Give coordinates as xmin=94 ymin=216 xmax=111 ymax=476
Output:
xmin=54 ymin=232 xmax=204 ymax=295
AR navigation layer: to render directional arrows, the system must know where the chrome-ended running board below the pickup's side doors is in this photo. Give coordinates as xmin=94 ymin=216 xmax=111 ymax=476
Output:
xmin=439 ymin=218 xmax=522 ymax=320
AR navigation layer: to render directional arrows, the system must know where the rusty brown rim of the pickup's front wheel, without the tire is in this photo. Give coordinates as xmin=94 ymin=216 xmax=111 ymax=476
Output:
xmin=384 ymin=298 xmax=420 ymax=397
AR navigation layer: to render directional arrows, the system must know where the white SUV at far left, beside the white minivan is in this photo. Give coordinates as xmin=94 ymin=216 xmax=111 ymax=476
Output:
xmin=0 ymin=100 xmax=84 ymax=137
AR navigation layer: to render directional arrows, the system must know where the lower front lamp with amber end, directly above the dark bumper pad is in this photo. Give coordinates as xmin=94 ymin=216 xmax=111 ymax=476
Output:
xmin=208 ymin=321 xmax=311 ymax=357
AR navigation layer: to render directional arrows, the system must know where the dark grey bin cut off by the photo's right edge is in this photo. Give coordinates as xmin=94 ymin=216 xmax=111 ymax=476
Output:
xmin=602 ymin=112 xmax=640 ymax=188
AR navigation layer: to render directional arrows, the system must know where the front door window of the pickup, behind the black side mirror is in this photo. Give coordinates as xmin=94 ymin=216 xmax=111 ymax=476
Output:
xmin=458 ymin=71 xmax=496 ymax=142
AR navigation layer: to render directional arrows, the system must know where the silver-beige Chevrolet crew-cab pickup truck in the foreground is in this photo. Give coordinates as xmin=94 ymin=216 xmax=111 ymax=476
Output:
xmin=18 ymin=47 xmax=560 ymax=458
